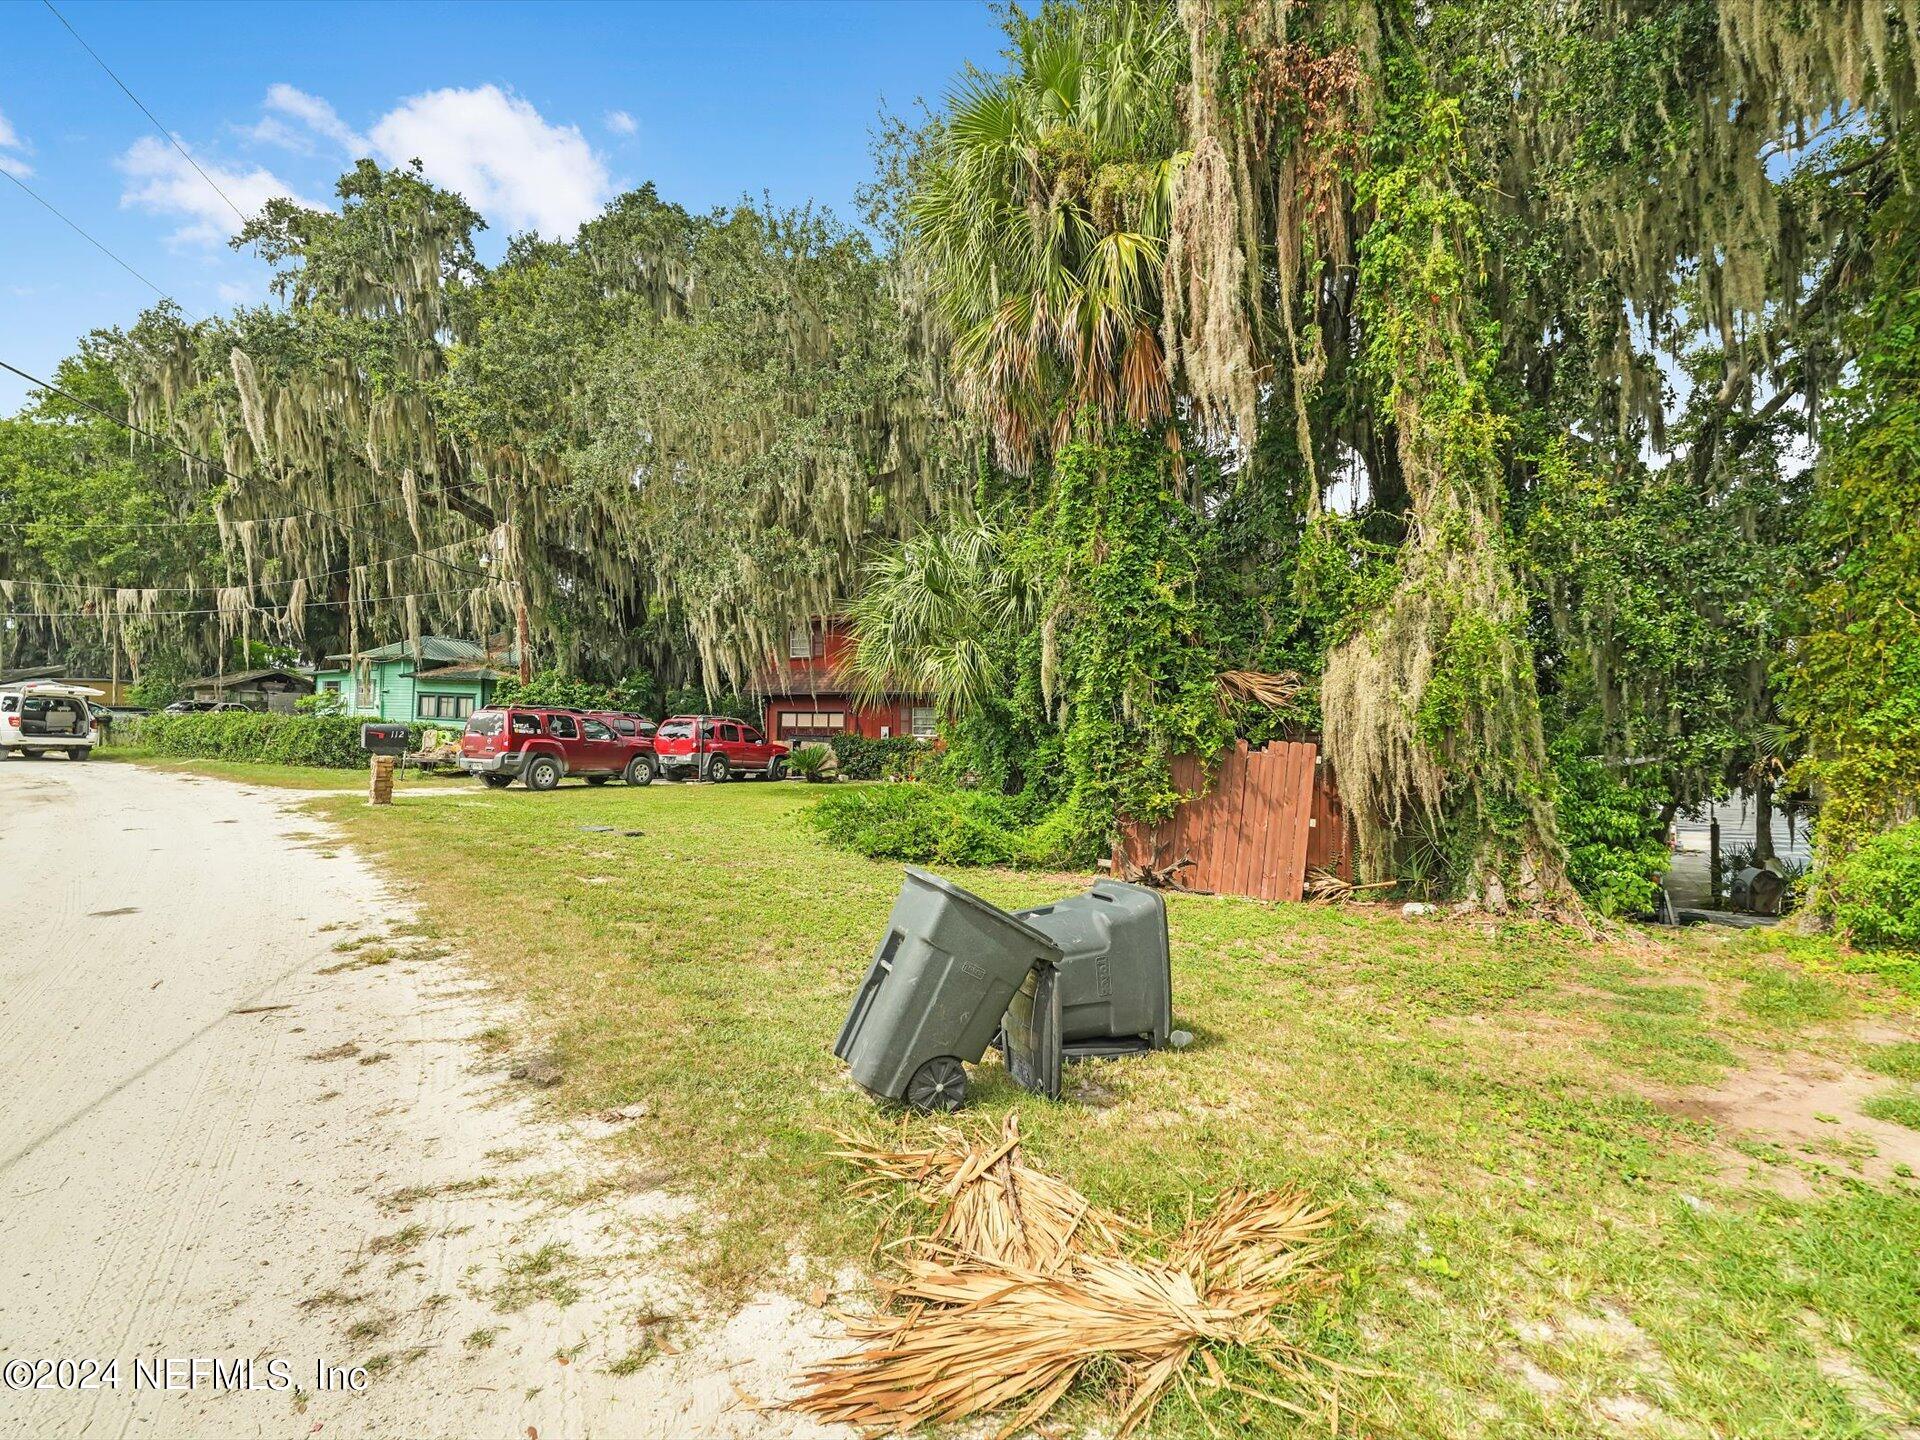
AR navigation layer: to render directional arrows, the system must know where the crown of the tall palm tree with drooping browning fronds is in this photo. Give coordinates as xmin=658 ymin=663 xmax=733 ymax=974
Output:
xmin=906 ymin=0 xmax=1187 ymax=472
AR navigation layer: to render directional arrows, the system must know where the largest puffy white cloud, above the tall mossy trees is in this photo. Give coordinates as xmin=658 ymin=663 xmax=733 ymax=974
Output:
xmin=371 ymin=84 xmax=611 ymax=238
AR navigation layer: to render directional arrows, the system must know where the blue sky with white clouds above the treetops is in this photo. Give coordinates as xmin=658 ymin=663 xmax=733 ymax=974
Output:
xmin=0 ymin=0 xmax=1000 ymax=413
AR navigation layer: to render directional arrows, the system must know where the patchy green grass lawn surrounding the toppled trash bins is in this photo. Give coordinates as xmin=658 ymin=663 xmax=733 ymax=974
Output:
xmin=228 ymin=766 xmax=1920 ymax=1440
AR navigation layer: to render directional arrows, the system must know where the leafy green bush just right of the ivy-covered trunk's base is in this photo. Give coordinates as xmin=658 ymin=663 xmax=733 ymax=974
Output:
xmin=1553 ymin=733 xmax=1668 ymax=916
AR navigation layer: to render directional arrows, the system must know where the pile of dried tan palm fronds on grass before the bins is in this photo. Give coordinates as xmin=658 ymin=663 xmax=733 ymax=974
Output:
xmin=789 ymin=1116 xmax=1332 ymax=1436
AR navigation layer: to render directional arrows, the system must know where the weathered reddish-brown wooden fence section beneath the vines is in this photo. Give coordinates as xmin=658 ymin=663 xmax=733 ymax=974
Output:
xmin=1114 ymin=741 xmax=1354 ymax=900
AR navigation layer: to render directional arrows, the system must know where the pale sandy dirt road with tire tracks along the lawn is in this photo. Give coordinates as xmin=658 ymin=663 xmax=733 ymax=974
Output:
xmin=0 ymin=760 xmax=848 ymax=1440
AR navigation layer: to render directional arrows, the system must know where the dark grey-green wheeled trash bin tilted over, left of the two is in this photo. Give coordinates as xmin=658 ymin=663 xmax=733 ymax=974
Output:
xmin=833 ymin=866 xmax=1062 ymax=1110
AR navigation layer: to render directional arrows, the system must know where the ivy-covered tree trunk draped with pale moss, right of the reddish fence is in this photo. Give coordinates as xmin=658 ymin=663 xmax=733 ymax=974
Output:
xmin=1321 ymin=54 xmax=1574 ymax=910
